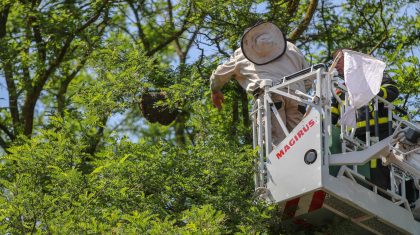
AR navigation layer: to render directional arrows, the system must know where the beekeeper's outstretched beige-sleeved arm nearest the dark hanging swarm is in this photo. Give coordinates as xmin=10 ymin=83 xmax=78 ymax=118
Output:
xmin=210 ymin=52 xmax=240 ymax=110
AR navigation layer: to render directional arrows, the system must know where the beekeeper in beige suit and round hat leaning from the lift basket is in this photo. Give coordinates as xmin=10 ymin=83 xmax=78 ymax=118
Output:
xmin=210 ymin=22 xmax=310 ymax=144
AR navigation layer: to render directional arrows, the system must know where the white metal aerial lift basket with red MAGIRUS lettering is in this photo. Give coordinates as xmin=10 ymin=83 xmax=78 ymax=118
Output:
xmin=252 ymin=64 xmax=420 ymax=234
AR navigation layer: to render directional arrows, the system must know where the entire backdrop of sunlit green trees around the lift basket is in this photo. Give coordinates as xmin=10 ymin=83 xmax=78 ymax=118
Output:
xmin=0 ymin=0 xmax=420 ymax=234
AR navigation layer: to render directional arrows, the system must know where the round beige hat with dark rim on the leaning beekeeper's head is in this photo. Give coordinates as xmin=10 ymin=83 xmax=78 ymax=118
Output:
xmin=241 ymin=22 xmax=286 ymax=65
